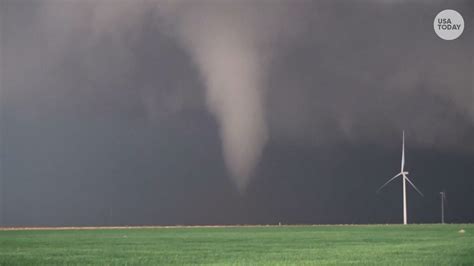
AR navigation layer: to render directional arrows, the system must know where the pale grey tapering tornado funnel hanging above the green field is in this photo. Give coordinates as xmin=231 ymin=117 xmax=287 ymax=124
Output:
xmin=158 ymin=2 xmax=268 ymax=190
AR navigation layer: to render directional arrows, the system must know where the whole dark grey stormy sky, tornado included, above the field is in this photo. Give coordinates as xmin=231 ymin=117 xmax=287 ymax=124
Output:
xmin=0 ymin=0 xmax=474 ymax=226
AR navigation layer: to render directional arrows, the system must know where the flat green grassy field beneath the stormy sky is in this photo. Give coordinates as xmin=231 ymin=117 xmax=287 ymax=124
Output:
xmin=0 ymin=224 xmax=474 ymax=265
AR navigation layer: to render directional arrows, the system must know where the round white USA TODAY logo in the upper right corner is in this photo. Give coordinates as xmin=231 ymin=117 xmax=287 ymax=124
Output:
xmin=433 ymin=9 xmax=464 ymax=41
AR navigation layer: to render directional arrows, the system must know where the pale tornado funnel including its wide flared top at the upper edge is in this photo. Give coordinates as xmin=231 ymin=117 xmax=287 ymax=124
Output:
xmin=156 ymin=1 xmax=304 ymax=191
